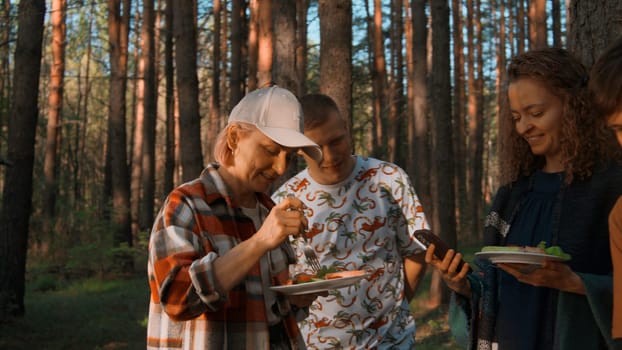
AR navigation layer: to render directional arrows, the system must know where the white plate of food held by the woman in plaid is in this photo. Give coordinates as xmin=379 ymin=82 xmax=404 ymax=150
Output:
xmin=270 ymin=270 xmax=370 ymax=295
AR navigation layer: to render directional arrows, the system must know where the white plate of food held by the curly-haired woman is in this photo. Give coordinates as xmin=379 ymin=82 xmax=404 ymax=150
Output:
xmin=475 ymin=246 xmax=570 ymax=265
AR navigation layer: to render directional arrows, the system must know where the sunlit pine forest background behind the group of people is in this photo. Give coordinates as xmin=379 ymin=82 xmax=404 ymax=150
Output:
xmin=0 ymin=0 xmax=622 ymax=344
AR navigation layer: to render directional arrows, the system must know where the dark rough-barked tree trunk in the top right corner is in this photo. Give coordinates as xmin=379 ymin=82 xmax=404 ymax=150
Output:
xmin=567 ymin=0 xmax=622 ymax=67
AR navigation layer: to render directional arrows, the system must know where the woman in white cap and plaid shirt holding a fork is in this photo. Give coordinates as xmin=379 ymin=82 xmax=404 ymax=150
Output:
xmin=147 ymin=86 xmax=322 ymax=349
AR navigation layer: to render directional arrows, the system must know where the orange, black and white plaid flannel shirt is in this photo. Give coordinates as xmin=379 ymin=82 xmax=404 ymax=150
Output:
xmin=147 ymin=165 xmax=304 ymax=349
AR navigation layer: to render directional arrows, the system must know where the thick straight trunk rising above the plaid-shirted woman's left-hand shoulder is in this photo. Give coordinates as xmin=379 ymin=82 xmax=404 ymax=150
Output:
xmin=173 ymin=0 xmax=203 ymax=182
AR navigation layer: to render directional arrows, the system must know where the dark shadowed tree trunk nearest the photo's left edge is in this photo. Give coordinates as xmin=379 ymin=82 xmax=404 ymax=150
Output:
xmin=0 ymin=0 xmax=45 ymax=323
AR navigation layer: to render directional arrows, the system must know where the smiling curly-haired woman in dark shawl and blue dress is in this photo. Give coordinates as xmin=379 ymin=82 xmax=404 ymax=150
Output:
xmin=426 ymin=48 xmax=622 ymax=350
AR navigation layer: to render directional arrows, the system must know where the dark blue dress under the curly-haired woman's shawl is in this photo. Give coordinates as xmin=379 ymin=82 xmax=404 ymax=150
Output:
xmin=495 ymin=171 xmax=563 ymax=350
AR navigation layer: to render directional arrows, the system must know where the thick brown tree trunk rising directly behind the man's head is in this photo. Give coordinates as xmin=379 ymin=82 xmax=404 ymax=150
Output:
xmin=319 ymin=0 xmax=352 ymax=126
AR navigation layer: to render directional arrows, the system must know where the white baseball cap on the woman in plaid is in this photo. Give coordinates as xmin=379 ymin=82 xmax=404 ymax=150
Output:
xmin=229 ymin=86 xmax=322 ymax=162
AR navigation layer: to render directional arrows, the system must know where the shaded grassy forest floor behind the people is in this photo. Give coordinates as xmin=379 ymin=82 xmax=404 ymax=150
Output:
xmin=0 ymin=273 xmax=466 ymax=350
